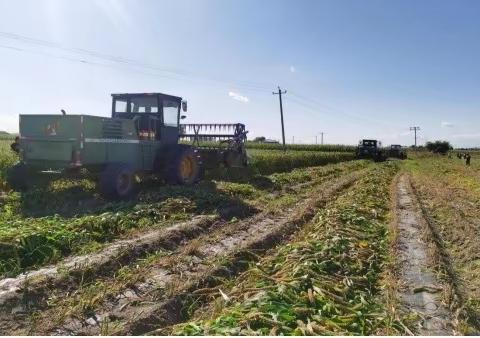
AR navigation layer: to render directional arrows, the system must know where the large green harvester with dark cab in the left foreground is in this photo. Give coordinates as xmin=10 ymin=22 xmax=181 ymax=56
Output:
xmin=7 ymin=93 xmax=247 ymax=199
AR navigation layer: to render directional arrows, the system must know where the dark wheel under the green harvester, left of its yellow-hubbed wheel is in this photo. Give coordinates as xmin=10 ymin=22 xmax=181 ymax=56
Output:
xmin=99 ymin=163 xmax=137 ymax=199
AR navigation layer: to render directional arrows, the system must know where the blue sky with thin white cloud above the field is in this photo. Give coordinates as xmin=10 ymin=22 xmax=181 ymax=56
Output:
xmin=0 ymin=0 xmax=480 ymax=146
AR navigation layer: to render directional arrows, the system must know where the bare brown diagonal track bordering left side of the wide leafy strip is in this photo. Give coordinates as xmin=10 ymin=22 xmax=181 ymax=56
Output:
xmin=34 ymin=170 xmax=367 ymax=335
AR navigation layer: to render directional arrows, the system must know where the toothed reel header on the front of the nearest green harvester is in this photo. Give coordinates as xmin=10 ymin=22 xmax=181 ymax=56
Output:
xmin=180 ymin=123 xmax=248 ymax=169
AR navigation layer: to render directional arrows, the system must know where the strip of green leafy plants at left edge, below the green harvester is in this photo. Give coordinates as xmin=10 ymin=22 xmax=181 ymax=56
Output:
xmin=0 ymin=198 xmax=195 ymax=275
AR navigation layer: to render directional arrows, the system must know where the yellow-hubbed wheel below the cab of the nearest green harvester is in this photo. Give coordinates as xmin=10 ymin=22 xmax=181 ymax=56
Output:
xmin=164 ymin=147 xmax=203 ymax=185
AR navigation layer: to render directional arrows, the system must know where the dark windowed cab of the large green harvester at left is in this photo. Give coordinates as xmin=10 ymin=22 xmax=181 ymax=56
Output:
xmin=112 ymin=93 xmax=186 ymax=144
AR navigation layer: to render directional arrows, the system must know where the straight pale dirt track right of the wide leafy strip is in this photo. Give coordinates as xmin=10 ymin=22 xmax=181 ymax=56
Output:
xmin=395 ymin=175 xmax=453 ymax=335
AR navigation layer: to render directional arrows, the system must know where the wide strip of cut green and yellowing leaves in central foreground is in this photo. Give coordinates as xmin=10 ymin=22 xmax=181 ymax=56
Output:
xmin=173 ymin=163 xmax=401 ymax=335
